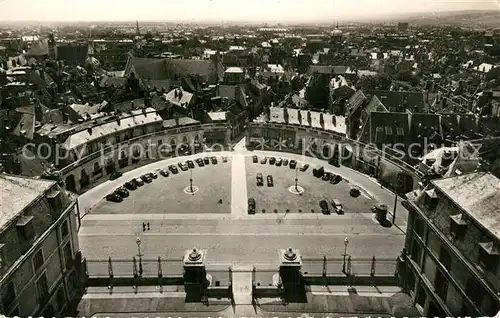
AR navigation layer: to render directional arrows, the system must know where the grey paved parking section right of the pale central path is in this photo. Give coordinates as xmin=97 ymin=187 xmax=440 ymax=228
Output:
xmin=245 ymin=157 xmax=376 ymax=217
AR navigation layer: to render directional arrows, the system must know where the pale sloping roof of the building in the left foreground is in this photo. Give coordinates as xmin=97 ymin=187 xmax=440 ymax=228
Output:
xmin=0 ymin=174 xmax=56 ymax=229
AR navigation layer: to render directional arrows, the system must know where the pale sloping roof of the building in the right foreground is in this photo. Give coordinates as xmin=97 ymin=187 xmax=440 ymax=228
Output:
xmin=433 ymin=172 xmax=500 ymax=240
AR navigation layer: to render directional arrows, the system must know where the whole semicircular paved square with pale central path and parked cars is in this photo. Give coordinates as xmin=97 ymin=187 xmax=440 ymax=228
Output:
xmin=79 ymin=152 xmax=405 ymax=272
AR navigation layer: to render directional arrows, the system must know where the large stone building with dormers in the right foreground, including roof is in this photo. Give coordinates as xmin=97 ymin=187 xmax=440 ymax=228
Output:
xmin=402 ymin=172 xmax=500 ymax=317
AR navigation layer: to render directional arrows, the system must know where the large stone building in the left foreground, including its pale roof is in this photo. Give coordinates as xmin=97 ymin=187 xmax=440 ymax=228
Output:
xmin=0 ymin=174 xmax=82 ymax=317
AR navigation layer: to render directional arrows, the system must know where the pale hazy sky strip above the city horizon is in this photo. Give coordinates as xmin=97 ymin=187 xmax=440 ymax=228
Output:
xmin=0 ymin=0 xmax=500 ymax=22
